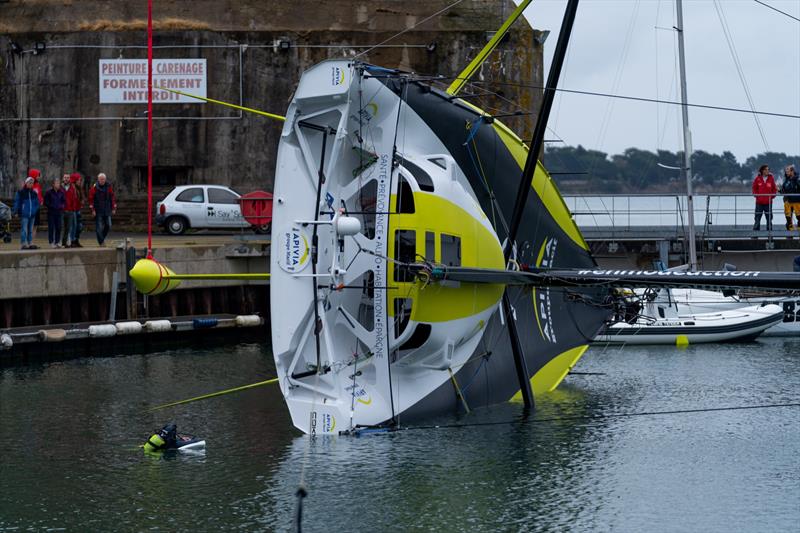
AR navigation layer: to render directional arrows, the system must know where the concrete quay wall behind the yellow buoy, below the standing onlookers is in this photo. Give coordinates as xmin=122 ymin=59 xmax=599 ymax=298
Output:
xmin=0 ymin=232 xmax=269 ymax=328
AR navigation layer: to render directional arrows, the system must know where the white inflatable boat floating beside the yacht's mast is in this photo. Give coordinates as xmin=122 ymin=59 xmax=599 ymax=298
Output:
xmin=595 ymin=305 xmax=783 ymax=345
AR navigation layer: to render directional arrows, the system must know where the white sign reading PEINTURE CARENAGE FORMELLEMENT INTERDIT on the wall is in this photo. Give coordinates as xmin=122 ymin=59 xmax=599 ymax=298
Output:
xmin=98 ymin=59 xmax=207 ymax=104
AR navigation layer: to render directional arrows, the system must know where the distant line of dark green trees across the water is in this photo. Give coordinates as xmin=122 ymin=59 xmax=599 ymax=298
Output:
xmin=543 ymin=145 xmax=800 ymax=194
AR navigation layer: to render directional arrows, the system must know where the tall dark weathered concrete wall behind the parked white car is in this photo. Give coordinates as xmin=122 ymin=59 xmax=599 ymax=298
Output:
xmin=0 ymin=0 xmax=542 ymax=197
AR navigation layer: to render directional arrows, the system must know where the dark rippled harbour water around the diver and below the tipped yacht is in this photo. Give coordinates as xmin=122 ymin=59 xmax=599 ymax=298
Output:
xmin=0 ymin=339 xmax=800 ymax=532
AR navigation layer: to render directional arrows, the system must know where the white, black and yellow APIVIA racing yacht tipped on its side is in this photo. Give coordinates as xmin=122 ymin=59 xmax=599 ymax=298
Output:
xmin=270 ymin=60 xmax=800 ymax=434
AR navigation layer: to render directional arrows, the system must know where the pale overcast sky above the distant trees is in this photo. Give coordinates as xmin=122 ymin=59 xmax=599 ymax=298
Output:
xmin=517 ymin=0 xmax=800 ymax=163
